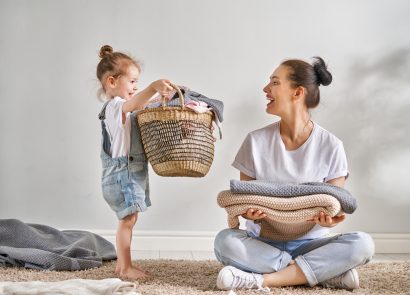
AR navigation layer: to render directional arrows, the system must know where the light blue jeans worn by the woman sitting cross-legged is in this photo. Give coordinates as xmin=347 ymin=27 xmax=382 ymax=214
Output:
xmin=214 ymin=229 xmax=374 ymax=286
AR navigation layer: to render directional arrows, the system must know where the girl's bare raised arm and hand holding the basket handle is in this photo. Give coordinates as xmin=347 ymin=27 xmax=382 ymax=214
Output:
xmin=122 ymin=79 xmax=173 ymax=113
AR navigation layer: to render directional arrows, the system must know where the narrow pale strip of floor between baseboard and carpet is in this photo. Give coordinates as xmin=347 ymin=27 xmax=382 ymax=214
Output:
xmin=131 ymin=251 xmax=410 ymax=262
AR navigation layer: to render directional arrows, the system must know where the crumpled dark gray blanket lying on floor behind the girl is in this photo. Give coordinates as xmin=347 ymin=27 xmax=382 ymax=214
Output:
xmin=0 ymin=219 xmax=117 ymax=270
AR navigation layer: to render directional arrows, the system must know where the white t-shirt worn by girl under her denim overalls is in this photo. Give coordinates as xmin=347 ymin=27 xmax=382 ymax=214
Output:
xmin=104 ymin=96 xmax=131 ymax=158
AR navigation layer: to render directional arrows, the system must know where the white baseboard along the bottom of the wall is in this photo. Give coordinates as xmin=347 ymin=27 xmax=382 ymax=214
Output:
xmin=90 ymin=230 xmax=410 ymax=253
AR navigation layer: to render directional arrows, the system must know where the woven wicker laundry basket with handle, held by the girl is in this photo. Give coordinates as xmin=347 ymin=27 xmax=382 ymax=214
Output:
xmin=137 ymin=85 xmax=214 ymax=177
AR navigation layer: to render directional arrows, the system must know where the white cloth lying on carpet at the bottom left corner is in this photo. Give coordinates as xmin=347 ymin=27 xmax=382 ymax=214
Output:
xmin=0 ymin=278 xmax=140 ymax=295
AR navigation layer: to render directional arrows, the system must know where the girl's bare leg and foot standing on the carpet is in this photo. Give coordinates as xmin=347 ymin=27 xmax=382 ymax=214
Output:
xmin=115 ymin=213 xmax=147 ymax=279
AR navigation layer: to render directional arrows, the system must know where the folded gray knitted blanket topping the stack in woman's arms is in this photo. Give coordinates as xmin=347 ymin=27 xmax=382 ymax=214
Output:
xmin=231 ymin=179 xmax=357 ymax=214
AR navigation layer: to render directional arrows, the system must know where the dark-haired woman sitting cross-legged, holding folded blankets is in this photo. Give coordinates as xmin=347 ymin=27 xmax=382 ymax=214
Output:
xmin=215 ymin=57 xmax=374 ymax=290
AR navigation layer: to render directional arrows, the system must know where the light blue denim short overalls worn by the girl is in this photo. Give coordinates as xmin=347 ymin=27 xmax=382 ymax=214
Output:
xmin=98 ymin=101 xmax=151 ymax=219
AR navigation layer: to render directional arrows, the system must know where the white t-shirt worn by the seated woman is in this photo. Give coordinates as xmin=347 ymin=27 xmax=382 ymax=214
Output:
xmin=232 ymin=121 xmax=349 ymax=239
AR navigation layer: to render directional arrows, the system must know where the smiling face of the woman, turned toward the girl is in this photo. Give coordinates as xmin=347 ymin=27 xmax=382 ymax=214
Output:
xmin=263 ymin=66 xmax=295 ymax=117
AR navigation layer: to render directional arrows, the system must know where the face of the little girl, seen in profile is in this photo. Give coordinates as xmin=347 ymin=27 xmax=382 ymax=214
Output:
xmin=112 ymin=65 xmax=140 ymax=100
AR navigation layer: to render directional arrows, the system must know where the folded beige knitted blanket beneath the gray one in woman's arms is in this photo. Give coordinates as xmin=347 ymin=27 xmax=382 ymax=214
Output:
xmin=217 ymin=191 xmax=341 ymax=240
